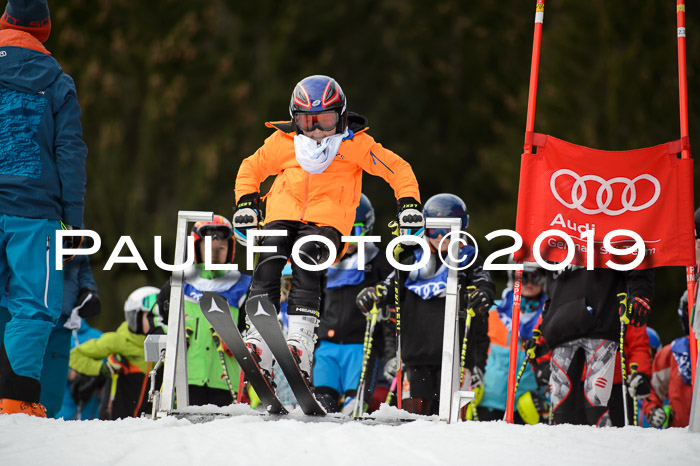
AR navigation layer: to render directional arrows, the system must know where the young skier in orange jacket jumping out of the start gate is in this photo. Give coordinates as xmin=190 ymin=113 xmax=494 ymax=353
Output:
xmin=233 ymin=75 xmax=424 ymax=382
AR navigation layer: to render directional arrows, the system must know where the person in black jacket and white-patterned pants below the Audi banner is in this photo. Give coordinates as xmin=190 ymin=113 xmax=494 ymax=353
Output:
xmin=525 ymin=265 xmax=654 ymax=427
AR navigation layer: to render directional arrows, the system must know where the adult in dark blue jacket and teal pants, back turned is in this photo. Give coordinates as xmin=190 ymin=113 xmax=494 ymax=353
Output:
xmin=0 ymin=0 xmax=87 ymax=417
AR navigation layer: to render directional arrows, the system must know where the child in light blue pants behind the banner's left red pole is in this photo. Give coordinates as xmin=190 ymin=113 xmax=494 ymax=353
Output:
xmin=476 ymin=263 xmax=546 ymax=424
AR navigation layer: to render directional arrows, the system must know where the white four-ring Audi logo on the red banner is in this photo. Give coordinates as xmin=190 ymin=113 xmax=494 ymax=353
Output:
xmin=549 ymin=168 xmax=661 ymax=216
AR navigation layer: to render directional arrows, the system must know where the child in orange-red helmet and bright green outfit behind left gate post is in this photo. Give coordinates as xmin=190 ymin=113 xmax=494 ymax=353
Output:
xmin=145 ymin=215 xmax=251 ymax=406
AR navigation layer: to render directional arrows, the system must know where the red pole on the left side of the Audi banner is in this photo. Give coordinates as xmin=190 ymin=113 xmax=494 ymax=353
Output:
xmin=505 ymin=0 xmax=544 ymax=424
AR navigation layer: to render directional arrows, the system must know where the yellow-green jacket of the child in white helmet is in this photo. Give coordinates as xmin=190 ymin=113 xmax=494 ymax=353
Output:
xmin=69 ymin=322 xmax=148 ymax=375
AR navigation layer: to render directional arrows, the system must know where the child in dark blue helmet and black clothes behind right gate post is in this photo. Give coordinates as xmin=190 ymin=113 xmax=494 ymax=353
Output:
xmin=357 ymin=194 xmax=495 ymax=414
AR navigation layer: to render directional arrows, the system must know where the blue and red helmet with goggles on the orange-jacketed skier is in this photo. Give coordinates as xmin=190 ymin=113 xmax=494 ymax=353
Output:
xmin=289 ymin=75 xmax=348 ymax=134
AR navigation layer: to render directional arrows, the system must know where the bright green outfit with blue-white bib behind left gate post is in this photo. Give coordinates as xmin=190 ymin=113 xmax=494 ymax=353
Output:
xmin=149 ymin=269 xmax=251 ymax=390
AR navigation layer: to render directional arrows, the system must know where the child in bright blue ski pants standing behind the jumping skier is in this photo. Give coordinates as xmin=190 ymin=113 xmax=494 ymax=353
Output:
xmin=313 ymin=194 xmax=393 ymax=413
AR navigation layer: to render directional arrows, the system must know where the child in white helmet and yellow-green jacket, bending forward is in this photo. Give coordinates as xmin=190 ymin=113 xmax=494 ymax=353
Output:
xmin=69 ymin=286 xmax=158 ymax=420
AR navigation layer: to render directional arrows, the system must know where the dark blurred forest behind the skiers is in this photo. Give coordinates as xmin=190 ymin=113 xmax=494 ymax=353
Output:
xmin=46 ymin=0 xmax=700 ymax=342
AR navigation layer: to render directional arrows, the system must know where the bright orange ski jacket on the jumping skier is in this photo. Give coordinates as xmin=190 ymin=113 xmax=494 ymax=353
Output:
xmin=235 ymin=114 xmax=420 ymax=235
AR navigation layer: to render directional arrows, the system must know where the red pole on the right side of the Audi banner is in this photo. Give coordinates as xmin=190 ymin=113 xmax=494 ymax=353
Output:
xmin=676 ymin=0 xmax=698 ymax=383
